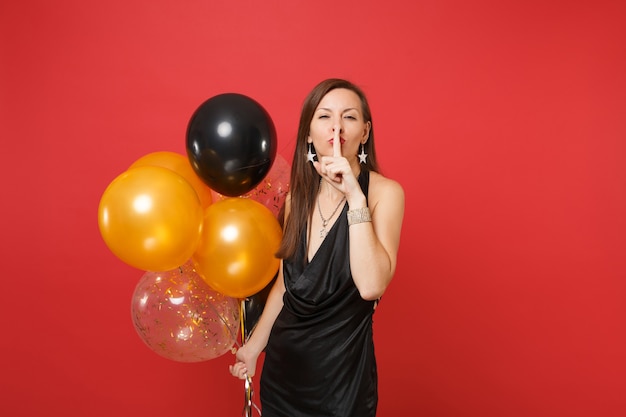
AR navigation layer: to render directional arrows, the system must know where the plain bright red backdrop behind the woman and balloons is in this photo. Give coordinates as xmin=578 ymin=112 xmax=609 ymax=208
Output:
xmin=0 ymin=0 xmax=626 ymax=417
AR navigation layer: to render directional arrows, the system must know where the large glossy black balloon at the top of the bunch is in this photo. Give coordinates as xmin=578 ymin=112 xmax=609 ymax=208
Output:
xmin=187 ymin=93 xmax=277 ymax=197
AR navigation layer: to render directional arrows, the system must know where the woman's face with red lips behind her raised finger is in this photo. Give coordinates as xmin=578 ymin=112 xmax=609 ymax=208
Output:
xmin=308 ymin=88 xmax=370 ymax=161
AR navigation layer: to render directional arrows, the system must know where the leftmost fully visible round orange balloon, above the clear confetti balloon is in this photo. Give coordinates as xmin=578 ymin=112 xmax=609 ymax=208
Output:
xmin=98 ymin=166 xmax=203 ymax=271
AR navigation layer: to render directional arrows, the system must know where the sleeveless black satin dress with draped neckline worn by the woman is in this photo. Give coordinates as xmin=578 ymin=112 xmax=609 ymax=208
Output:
xmin=260 ymin=171 xmax=378 ymax=417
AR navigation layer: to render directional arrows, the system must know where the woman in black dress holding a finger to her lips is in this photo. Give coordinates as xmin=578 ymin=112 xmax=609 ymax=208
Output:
xmin=230 ymin=79 xmax=404 ymax=417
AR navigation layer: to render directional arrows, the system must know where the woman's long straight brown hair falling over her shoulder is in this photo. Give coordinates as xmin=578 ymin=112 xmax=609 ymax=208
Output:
xmin=276 ymin=78 xmax=378 ymax=259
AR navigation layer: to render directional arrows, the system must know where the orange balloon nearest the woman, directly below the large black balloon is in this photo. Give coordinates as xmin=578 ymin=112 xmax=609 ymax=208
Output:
xmin=193 ymin=198 xmax=282 ymax=298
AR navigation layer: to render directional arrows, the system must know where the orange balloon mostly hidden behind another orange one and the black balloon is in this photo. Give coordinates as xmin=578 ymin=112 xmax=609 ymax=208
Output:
xmin=130 ymin=151 xmax=213 ymax=208
